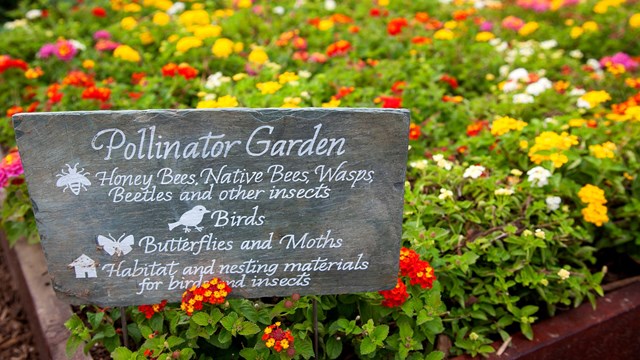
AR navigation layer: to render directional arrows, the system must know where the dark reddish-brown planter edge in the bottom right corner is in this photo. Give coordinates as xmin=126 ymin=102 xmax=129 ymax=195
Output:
xmin=453 ymin=282 xmax=640 ymax=360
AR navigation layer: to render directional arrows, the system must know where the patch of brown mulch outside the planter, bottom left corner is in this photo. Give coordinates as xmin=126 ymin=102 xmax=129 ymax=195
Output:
xmin=0 ymin=240 xmax=38 ymax=360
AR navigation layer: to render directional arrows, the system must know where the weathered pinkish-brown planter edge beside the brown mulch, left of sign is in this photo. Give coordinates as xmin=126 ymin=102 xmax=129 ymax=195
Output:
xmin=0 ymin=231 xmax=92 ymax=360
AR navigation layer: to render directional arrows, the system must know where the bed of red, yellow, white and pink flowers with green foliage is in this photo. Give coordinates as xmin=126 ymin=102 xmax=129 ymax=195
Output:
xmin=0 ymin=0 xmax=640 ymax=359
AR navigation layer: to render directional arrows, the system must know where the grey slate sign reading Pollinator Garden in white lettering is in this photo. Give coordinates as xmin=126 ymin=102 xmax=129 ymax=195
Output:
xmin=14 ymin=109 xmax=409 ymax=306
